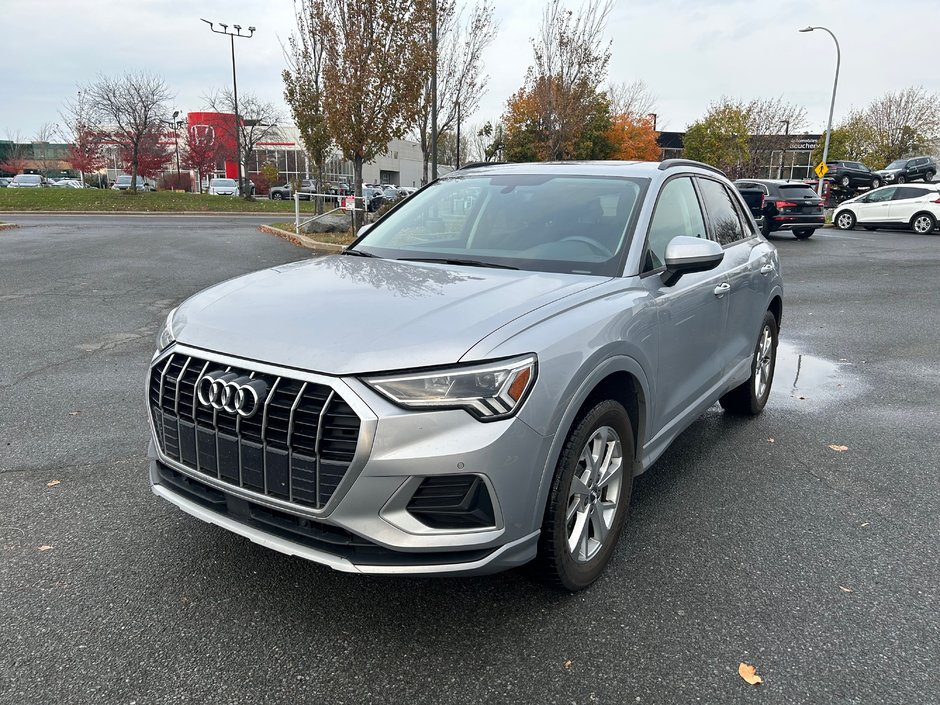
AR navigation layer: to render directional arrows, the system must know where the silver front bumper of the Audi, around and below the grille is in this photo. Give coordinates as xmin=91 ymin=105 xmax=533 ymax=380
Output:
xmin=150 ymin=346 xmax=552 ymax=575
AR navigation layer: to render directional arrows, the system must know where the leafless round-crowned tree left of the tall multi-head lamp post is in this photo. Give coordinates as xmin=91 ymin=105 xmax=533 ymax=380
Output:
xmin=83 ymin=71 xmax=174 ymax=193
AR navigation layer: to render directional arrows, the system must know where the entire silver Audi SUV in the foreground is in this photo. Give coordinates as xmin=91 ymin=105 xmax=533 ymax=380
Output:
xmin=147 ymin=160 xmax=783 ymax=590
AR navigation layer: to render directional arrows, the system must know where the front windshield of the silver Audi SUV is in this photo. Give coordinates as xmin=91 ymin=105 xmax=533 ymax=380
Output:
xmin=354 ymin=174 xmax=648 ymax=276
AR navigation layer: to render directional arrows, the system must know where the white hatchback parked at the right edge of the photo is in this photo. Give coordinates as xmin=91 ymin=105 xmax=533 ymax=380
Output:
xmin=832 ymin=184 xmax=940 ymax=235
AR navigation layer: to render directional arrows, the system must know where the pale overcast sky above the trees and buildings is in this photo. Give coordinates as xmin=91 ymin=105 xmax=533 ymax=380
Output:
xmin=0 ymin=0 xmax=940 ymax=139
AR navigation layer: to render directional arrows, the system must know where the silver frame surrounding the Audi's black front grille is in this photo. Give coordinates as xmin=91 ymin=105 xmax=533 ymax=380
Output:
xmin=146 ymin=342 xmax=378 ymax=519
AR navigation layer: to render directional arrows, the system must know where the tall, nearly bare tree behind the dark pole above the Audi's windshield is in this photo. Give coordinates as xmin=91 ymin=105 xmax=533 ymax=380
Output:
xmin=415 ymin=0 xmax=499 ymax=183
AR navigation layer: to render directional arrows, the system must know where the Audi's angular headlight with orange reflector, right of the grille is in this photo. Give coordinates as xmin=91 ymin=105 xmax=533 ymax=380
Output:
xmin=363 ymin=355 xmax=538 ymax=421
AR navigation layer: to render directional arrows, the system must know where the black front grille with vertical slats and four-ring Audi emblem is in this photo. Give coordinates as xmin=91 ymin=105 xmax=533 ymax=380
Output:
xmin=149 ymin=353 xmax=360 ymax=510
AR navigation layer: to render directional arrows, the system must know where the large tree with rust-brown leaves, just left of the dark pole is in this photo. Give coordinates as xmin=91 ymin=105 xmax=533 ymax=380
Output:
xmin=311 ymin=0 xmax=433 ymax=225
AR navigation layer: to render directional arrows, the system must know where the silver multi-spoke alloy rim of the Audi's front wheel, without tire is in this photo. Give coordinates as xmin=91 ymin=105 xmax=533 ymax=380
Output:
xmin=565 ymin=426 xmax=623 ymax=563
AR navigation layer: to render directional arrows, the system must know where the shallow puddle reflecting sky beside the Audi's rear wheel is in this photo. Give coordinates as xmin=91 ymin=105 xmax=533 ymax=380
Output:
xmin=770 ymin=343 xmax=859 ymax=407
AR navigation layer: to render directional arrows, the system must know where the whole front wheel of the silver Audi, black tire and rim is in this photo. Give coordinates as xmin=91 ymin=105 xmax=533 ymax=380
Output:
xmin=534 ymin=399 xmax=634 ymax=592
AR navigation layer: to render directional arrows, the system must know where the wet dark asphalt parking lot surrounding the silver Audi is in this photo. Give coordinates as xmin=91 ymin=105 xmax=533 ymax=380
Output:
xmin=0 ymin=216 xmax=940 ymax=705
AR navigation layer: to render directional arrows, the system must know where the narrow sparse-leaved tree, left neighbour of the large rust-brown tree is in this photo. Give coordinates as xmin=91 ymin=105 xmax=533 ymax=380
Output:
xmin=281 ymin=0 xmax=333 ymax=213
